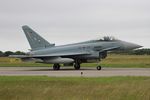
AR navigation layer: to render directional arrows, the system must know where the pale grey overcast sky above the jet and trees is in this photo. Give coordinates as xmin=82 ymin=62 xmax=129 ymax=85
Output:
xmin=0 ymin=0 xmax=150 ymax=51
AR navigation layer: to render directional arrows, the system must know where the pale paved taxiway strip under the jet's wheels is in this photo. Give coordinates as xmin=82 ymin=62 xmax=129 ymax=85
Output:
xmin=0 ymin=67 xmax=150 ymax=77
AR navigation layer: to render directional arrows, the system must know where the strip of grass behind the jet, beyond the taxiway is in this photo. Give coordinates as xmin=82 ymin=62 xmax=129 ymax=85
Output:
xmin=0 ymin=54 xmax=150 ymax=68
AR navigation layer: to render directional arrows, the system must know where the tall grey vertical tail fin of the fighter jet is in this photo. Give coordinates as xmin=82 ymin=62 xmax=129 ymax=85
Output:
xmin=22 ymin=25 xmax=55 ymax=51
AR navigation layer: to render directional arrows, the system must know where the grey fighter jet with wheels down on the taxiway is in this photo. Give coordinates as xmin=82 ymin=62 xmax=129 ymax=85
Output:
xmin=10 ymin=25 xmax=142 ymax=70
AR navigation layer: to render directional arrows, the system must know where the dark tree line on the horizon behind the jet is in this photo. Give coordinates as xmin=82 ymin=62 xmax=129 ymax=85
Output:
xmin=0 ymin=49 xmax=150 ymax=57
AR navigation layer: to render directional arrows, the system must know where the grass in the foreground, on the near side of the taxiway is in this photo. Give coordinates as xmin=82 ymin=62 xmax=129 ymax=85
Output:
xmin=0 ymin=76 xmax=150 ymax=100
